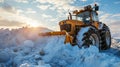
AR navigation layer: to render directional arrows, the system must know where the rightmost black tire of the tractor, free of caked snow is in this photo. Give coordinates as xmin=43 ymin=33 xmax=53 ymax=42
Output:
xmin=100 ymin=24 xmax=111 ymax=50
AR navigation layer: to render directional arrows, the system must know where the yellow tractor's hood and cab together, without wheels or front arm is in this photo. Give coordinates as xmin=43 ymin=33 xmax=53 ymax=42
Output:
xmin=59 ymin=5 xmax=99 ymax=34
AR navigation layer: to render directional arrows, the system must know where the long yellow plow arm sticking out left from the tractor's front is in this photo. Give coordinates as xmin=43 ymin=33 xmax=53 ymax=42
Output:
xmin=39 ymin=31 xmax=73 ymax=44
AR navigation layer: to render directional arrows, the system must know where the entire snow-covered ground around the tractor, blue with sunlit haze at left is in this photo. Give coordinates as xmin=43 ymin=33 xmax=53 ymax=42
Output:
xmin=0 ymin=28 xmax=120 ymax=67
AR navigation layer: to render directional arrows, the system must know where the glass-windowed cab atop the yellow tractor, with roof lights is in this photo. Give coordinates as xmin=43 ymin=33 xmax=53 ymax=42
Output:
xmin=68 ymin=4 xmax=99 ymax=24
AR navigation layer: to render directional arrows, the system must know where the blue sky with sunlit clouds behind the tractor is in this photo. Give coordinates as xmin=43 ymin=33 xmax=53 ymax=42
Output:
xmin=0 ymin=0 xmax=120 ymax=32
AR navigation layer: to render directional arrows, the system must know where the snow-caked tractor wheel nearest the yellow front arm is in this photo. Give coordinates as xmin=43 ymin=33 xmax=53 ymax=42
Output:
xmin=76 ymin=26 xmax=100 ymax=49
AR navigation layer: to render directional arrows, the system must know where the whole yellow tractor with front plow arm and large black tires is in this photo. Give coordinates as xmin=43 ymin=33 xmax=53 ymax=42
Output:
xmin=39 ymin=4 xmax=111 ymax=50
